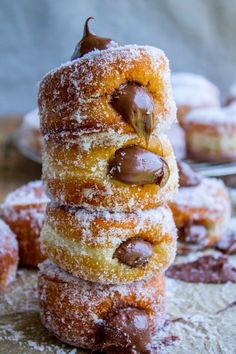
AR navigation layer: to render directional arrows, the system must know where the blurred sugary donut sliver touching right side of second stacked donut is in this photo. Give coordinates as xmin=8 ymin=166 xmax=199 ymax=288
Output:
xmin=166 ymin=124 xmax=187 ymax=160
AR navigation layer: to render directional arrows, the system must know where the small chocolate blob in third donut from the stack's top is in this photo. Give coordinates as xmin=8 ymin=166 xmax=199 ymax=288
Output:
xmin=113 ymin=236 xmax=153 ymax=268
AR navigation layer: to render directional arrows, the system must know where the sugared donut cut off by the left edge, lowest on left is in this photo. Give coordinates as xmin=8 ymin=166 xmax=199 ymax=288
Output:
xmin=0 ymin=219 xmax=18 ymax=293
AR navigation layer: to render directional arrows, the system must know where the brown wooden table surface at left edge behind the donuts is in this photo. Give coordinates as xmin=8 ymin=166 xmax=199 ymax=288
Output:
xmin=0 ymin=116 xmax=41 ymax=203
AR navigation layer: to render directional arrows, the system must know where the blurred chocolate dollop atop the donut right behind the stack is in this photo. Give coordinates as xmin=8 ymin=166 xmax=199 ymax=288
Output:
xmin=178 ymin=161 xmax=202 ymax=187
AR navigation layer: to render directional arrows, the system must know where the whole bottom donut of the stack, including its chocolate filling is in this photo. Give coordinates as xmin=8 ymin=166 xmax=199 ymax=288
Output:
xmin=38 ymin=260 xmax=165 ymax=354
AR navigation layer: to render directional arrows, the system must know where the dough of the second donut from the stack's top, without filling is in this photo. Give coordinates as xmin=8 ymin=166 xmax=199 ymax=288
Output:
xmin=43 ymin=132 xmax=178 ymax=212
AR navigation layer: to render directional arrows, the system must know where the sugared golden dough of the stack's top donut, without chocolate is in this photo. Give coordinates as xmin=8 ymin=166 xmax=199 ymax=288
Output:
xmin=38 ymin=45 xmax=176 ymax=135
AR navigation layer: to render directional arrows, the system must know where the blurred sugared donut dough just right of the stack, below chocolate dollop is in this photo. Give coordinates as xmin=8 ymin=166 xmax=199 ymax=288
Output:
xmin=169 ymin=178 xmax=231 ymax=253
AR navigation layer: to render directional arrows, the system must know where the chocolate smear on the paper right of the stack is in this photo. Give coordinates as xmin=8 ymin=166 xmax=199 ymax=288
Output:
xmin=166 ymin=255 xmax=236 ymax=284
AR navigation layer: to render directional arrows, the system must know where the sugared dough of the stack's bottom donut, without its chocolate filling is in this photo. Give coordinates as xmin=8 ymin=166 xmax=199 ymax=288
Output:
xmin=38 ymin=261 xmax=165 ymax=349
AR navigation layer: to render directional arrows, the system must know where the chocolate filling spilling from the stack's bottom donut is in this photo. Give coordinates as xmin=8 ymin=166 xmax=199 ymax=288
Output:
xmin=98 ymin=307 xmax=154 ymax=354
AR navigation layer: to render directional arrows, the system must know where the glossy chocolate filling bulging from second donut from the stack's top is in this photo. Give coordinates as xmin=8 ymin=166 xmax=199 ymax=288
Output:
xmin=108 ymin=145 xmax=169 ymax=187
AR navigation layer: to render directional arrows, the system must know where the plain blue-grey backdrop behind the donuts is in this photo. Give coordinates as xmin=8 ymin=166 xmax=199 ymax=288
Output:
xmin=0 ymin=0 xmax=236 ymax=114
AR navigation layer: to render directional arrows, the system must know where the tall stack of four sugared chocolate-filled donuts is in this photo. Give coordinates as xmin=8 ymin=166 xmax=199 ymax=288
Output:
xmin=39 ymin=19 xmax=178 ymax=353
